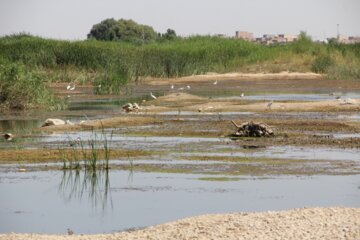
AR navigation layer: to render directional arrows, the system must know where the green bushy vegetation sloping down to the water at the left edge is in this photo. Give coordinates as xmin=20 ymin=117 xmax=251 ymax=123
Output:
xmin=0 ymin=60 xmax=64 ymax=110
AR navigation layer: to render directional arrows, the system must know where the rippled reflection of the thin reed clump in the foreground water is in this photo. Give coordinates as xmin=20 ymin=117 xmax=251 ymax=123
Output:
xmin=59 ymin=169 xmax=113 ymax=210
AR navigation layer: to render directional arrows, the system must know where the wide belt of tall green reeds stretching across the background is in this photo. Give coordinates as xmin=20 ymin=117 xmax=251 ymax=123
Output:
xmin=0 ymin=34 xmax=360 ymax=109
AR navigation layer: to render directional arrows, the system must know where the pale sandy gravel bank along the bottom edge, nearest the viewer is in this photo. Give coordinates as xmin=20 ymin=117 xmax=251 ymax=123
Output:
xmin=0 ymin=207 xmax=360 ymax=240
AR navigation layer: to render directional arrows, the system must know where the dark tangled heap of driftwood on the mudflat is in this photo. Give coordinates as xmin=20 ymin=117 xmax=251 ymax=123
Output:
xmin=231 ymin=121 xmax=274 ymax=137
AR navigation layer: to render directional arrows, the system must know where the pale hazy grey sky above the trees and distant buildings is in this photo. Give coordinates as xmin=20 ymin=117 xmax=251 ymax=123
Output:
xmin=0 ymin=0 xmax=360 ymax=40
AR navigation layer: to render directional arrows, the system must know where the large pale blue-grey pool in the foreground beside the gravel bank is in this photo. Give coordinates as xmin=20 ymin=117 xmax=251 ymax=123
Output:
xmin=0 ymin=171 xmax=360 ymax=234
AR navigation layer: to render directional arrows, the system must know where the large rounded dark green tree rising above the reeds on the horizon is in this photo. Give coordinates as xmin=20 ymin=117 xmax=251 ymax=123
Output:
xmin=87 ymin=18 xmax=157 ymax=43
